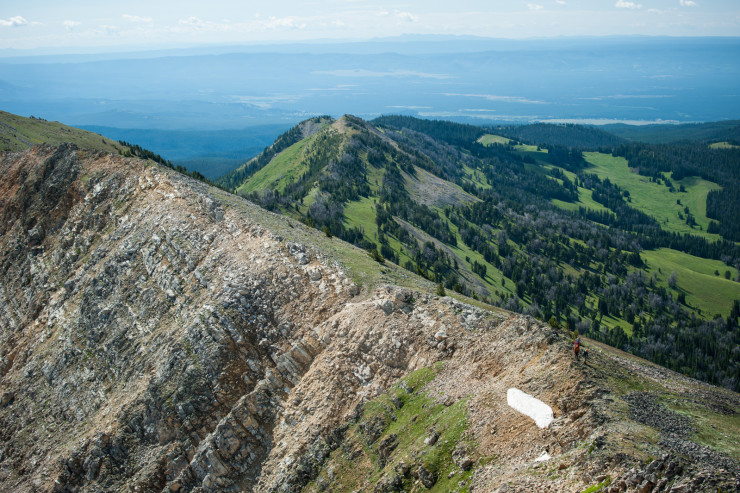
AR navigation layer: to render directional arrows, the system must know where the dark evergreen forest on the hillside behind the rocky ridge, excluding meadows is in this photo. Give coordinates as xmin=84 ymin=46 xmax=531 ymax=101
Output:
xmin=225 ymin=117 xmax=740 ymax=389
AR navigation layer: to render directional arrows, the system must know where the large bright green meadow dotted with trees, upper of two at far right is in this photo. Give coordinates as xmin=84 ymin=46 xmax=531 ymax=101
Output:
xmin=583 ymin=152 xmax=720 ymax=240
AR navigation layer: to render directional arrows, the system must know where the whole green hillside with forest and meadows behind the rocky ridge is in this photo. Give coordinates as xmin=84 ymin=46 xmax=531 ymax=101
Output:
xmin=215 ymin=116 xmax=740 ymax=389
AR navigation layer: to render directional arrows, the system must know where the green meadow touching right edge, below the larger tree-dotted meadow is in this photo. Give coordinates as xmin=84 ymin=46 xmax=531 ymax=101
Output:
xmin=641 ymin=248 xmax=740 ymax=316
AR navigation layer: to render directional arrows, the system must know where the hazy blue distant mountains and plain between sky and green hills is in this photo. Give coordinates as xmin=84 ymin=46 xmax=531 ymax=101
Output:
xmin=0 ymin=37 xmax=740 ymax=130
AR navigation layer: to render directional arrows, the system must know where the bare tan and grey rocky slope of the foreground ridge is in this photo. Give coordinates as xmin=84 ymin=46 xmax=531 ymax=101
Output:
xmin=0 ymin=146 xmax=740 ymax=491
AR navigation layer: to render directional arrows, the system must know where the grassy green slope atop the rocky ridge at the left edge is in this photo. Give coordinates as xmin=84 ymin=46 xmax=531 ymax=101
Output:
xmin=0 ymin=111 xmax=124 ymax=154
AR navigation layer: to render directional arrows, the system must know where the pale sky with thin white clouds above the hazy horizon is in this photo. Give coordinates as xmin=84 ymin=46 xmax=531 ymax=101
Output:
xmin=0 ymin=0 xmax=740 ymax=52
